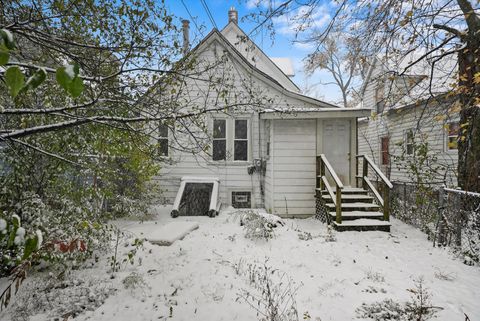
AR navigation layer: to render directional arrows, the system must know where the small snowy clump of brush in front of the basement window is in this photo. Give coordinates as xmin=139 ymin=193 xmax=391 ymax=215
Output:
xmin=240 ymin=210 xmax=279 ymax=240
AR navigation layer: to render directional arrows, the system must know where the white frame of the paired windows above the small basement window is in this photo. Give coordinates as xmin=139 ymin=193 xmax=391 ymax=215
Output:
xmin=210 ymin=115 xmax=252 ymax=164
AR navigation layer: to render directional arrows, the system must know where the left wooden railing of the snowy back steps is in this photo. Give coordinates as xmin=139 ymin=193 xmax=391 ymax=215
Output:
xmin=317 ymin=154 xmax=343 ymax=224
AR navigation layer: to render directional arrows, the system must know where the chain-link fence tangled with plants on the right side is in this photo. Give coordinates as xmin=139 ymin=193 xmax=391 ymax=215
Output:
xmin=391 ymin=182 xmax=480 ymax=262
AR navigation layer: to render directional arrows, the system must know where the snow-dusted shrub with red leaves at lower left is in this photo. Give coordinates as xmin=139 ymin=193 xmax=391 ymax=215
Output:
xmin=0 ymin=192 xmax=110 ymax=276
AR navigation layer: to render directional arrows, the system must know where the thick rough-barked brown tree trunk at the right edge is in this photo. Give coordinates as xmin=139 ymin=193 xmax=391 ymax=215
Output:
xmin=458 ymin=35 xmax=480 ymax=192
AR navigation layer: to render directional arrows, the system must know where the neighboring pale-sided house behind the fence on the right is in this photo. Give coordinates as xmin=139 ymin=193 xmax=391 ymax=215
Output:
xmin=358 ymin=54 xmax=459 ymax=186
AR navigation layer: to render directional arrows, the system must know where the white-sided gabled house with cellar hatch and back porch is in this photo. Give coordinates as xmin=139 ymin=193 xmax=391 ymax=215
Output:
xmin=156 ymin=9 xmax=370 ymax=217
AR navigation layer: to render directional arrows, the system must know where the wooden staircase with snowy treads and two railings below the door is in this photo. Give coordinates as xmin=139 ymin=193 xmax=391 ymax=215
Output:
xmin=316 ymin=154 xmax=393 ymax=232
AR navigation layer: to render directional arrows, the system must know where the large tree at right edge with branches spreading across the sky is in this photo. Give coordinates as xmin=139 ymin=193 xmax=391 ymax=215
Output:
xmin=246 ymin=0 xmax=480 ymax=191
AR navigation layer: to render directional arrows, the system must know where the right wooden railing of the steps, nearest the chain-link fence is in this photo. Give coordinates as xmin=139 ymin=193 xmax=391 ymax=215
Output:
xmin=357 ymin=155 xmax=393 ymax=221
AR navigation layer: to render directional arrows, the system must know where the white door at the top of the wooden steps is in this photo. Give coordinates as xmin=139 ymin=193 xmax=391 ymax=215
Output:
xmin=321 ymin=119 xmax=350 ymax=186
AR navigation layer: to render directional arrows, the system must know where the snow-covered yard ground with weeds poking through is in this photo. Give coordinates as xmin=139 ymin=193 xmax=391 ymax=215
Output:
xmin=0 ymin=208 xmax=480 ymax=321
